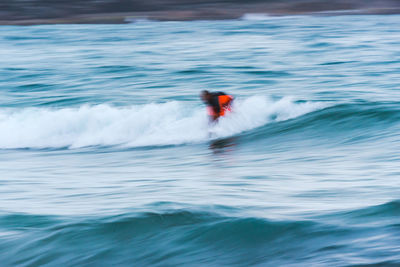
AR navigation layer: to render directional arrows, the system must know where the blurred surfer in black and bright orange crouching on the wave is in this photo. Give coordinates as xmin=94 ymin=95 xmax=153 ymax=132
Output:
xmin=201 ymin=90 xmax=233 ymax=122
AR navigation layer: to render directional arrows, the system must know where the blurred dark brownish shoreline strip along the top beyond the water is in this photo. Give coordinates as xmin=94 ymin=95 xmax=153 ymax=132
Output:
xmin=0 ymin=0 xmax=400 ymax=25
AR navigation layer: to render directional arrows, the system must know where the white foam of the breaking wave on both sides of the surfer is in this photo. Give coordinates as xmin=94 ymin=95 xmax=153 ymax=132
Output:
xmin=0 ymin=96 xmax=323 ymax=149
